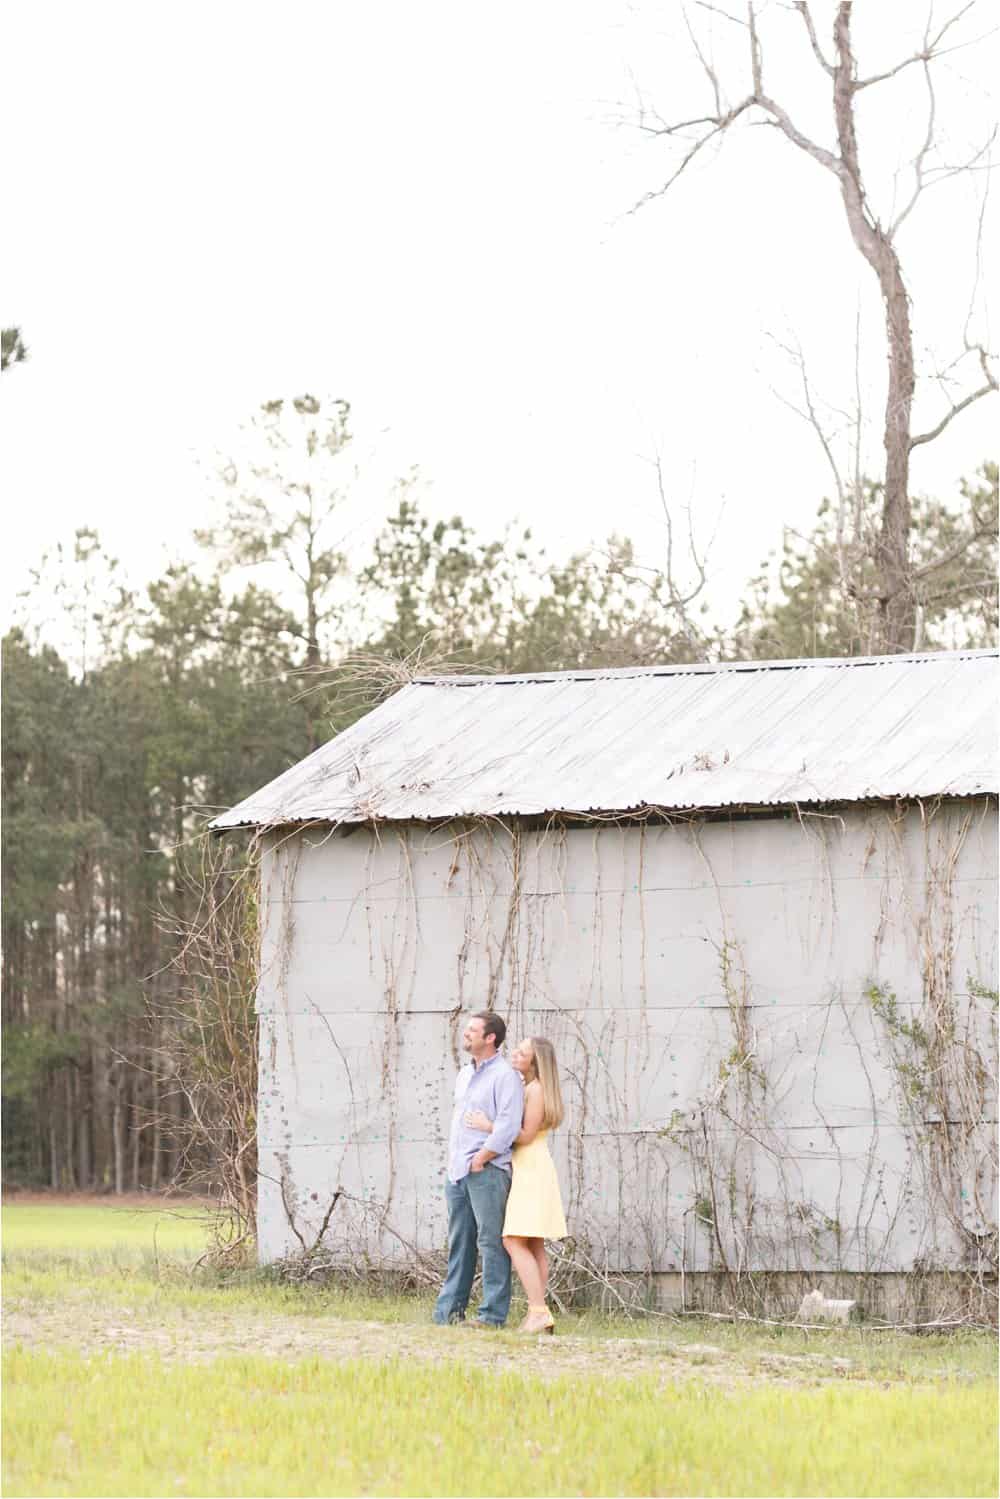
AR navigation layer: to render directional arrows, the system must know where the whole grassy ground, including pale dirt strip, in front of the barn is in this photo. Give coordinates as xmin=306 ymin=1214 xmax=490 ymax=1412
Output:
xmin=3 ymin=1204 xmax=999 ymax=1496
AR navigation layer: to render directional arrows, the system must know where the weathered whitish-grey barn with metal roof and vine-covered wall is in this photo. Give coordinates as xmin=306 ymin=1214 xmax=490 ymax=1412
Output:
xmin=213 ymin=652 xmax=997 ymax=1315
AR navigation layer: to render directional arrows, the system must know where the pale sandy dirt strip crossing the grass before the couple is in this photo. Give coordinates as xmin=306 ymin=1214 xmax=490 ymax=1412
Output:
xmin=3 ymin=1297 xmax=864 ymax=1385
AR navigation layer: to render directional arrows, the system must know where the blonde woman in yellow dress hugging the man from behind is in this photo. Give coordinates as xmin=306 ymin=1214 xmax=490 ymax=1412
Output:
xmin=465 ymin=1036 xmax=567 ymax=1333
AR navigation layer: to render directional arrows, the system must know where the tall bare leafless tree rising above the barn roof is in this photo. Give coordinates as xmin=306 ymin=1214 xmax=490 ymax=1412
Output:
xmin=629 ymin=0 xmax=997 ymax=652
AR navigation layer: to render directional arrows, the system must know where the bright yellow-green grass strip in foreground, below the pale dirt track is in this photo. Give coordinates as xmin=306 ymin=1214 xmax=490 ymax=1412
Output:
xmin=4 ymin=1351 xmax=997 ymax=1495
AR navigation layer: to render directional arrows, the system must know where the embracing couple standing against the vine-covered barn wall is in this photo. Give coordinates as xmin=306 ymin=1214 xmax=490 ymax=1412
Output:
xmin=433 ymin=1010 xmax=567 ymax=1333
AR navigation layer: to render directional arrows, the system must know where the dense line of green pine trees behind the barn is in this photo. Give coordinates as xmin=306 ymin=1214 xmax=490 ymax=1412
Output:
xmin=3 ymin=397 xmax=997 ymax=1192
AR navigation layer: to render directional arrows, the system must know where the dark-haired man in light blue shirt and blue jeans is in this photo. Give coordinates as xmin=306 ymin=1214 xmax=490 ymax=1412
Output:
xmin=433 ymin=1010 xmax=525 ymax=1327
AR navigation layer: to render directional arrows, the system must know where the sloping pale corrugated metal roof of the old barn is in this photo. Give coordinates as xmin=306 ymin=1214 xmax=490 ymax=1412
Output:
xmin=211 ymin=651 xmax=997 ymax=830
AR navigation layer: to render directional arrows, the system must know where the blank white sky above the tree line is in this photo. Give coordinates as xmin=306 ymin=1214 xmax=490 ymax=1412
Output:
xmin=0 ymin=0 xmax=996 ymax=635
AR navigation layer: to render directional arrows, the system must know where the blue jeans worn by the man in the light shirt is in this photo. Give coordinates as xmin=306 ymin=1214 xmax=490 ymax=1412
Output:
xmin=433 ymin=1162 xmax=510 ymax=1327
